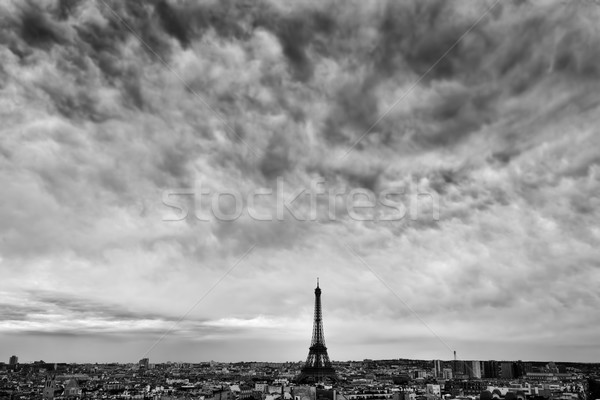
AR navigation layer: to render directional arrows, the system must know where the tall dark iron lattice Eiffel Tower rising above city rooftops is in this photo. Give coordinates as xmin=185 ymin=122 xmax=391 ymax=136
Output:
xmin=296 ymin=278 xmax=338 ymax=383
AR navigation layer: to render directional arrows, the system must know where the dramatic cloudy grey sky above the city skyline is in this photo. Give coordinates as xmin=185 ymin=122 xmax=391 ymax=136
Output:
xmin=0 ymin=0 xmax=600 ymax=362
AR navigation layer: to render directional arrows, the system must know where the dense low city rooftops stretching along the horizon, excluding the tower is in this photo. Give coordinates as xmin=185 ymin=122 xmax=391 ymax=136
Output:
xmin=0 ymin=358 xmax=600 ymax=400
